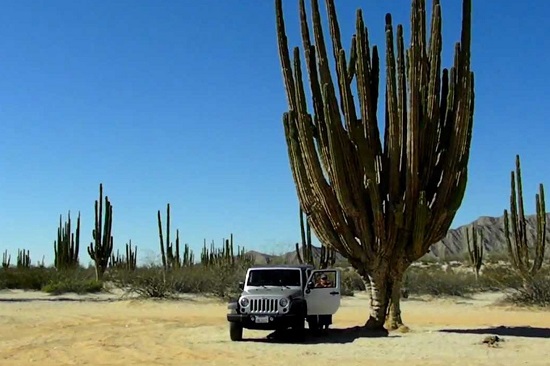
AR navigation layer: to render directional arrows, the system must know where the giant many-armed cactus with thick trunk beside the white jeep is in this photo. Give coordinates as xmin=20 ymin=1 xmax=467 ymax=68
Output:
xmin=275 ymin=0 xmax=474 ymax=328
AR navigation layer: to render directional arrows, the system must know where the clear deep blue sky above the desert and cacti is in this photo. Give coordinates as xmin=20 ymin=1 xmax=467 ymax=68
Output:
xmin=0 ymin=0 xmax=550 ymax=263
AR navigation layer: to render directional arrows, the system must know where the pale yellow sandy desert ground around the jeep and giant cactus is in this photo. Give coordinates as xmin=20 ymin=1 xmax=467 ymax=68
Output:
xmin=0 ymin=291 xmax=550 ymax=366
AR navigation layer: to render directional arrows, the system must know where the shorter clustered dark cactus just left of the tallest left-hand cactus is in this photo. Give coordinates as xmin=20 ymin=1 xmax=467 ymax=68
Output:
xmin=53 ymin=211 xmax=80 ymax=270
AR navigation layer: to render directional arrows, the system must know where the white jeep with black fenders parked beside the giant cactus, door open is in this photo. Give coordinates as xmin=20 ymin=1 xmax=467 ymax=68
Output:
xmin=227 ymin=265 xmax=341 ymax=341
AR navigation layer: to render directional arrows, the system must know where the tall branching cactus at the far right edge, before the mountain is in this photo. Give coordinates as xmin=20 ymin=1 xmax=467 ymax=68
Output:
xmin=504 ymin=155 xmax=546 ymax=290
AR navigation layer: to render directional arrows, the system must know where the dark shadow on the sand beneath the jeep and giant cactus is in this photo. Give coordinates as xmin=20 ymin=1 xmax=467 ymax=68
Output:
xmin=245 ymin=327 xmax=392 ymax=344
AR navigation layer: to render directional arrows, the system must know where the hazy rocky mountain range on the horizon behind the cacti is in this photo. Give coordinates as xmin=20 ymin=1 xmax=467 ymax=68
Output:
xmin=248 ymin=213 xmax=550 ymax=264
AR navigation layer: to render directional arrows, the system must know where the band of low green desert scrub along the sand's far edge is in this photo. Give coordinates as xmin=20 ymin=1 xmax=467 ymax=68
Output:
xmin=4 ymin=251 xmax=550 ymax=307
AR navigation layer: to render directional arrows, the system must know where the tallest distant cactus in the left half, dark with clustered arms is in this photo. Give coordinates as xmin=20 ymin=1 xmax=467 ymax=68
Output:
xmin=88 ymin=184 xmax=113 ymax=281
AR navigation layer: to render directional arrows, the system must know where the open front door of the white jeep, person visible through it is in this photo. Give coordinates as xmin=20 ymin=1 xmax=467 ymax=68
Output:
xmin=305 ymin=269 xmax=341 ymax=315
